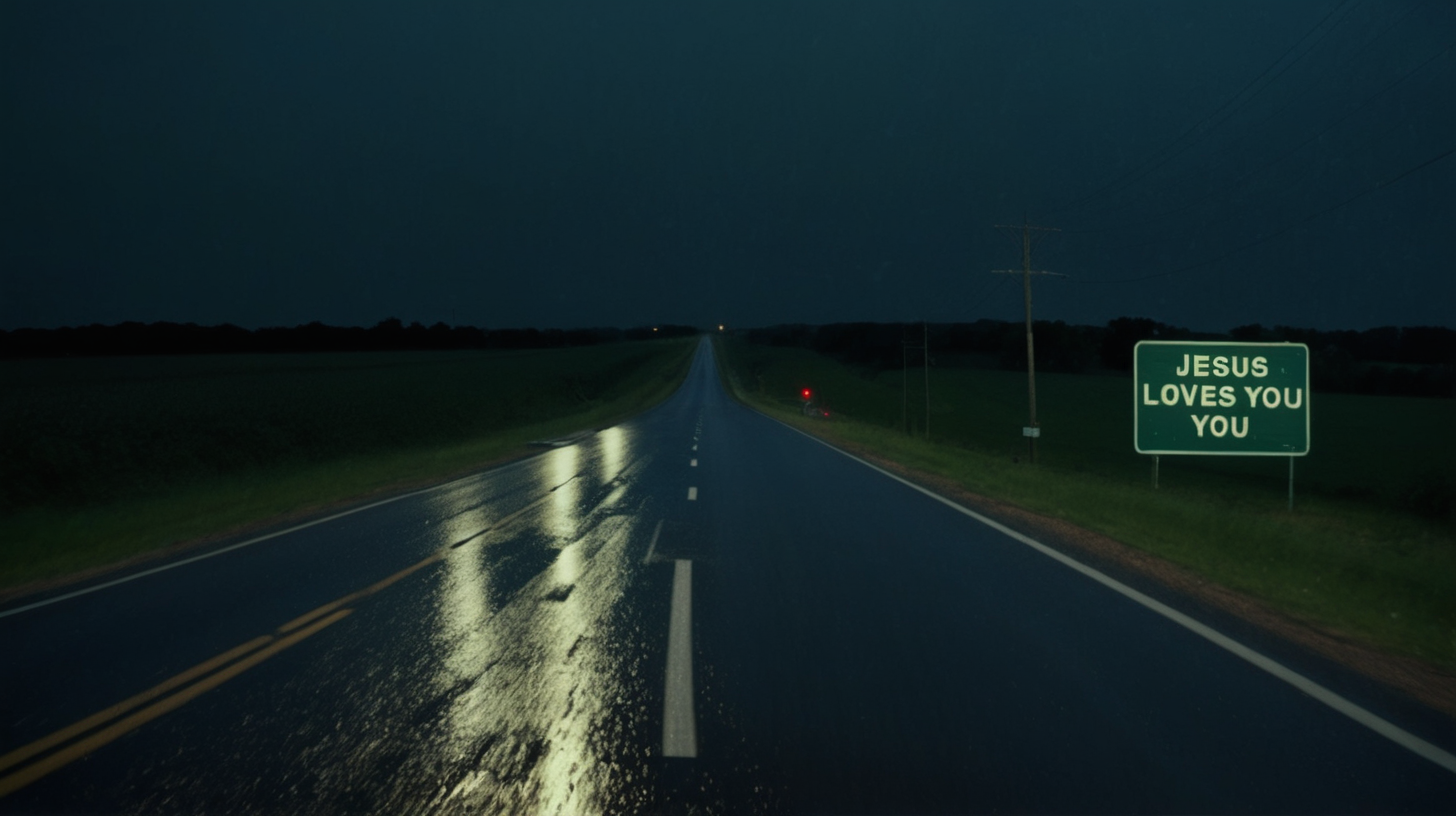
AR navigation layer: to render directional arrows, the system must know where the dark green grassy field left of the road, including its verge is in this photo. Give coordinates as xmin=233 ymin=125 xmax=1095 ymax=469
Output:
xmin=0 ymin=340 xmax=695 ymax=587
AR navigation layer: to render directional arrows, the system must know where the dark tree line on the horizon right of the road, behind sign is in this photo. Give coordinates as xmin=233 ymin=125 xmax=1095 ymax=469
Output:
xmin=737 ymin=318 xmax=1456 ymax=396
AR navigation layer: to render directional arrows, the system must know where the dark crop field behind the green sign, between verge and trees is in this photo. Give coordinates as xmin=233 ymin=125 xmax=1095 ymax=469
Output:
xmin=732 ymin=338 xmax=1456 ymax=520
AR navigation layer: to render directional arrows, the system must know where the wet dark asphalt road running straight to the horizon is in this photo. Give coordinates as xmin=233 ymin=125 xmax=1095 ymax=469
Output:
xmin=0 ymin=335 xmax=1456 ymax=815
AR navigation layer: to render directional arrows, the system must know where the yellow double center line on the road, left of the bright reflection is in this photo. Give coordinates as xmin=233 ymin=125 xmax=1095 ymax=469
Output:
xmin=0 ymin=551 xmax=444 ymax=797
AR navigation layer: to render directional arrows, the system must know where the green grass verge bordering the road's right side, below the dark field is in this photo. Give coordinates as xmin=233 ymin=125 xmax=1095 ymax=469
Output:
xmin=719 ymin=340 xmax=1456 ymax=676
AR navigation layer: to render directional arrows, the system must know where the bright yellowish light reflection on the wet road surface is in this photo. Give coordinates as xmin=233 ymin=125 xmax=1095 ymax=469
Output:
xmin=431 ymin=428 xmax=648 ymax=813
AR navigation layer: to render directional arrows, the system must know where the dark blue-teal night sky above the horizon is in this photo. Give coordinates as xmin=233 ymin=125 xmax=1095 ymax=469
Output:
xmin=0 ymin=0 xmax=1456 ymax=329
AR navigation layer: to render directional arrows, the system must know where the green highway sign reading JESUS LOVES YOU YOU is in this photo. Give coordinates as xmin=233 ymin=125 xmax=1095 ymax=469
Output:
xmin=1133 ymin=340 xmax=1309 ymax=456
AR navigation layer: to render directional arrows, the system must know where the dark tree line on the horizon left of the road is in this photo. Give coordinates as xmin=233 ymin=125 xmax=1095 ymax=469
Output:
xmin=0 ymin=318 xmax=697 ymax=358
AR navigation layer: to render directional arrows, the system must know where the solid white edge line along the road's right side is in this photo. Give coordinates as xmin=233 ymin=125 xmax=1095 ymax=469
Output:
xmin=760 ymin=414 xmax=1456 ymax=774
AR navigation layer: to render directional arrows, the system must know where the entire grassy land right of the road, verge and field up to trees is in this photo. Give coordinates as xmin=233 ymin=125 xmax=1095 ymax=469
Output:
xmin=719 ymin=340 xmax=1456 ymax=670
